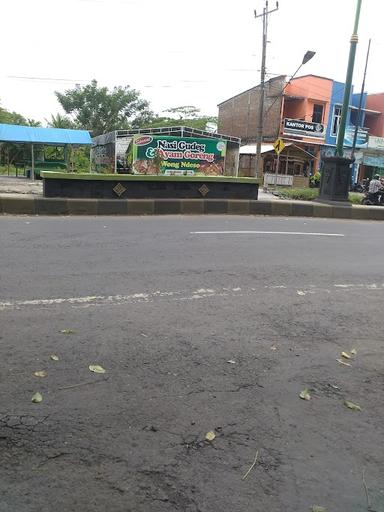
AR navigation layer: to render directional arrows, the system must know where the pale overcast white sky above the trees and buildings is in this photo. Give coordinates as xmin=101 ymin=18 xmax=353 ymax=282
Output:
xmin=0 ymin=0 xmax=384 ymax=123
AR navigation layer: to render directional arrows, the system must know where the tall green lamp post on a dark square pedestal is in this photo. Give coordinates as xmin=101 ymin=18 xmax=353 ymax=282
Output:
xmin=319 ymin=0 xmax=362 ymax=201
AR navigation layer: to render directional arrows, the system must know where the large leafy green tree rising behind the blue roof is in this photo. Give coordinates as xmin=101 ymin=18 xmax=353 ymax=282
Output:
xmin=55 ymin=80 xmax=153 ymax=136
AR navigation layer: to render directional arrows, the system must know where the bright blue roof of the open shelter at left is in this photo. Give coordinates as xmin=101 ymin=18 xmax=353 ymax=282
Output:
xmin=0 ymin=124 xmax=92 ymax=145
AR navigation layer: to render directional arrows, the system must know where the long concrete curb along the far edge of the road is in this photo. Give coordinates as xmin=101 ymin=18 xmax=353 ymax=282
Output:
xmin=0 ymin=195 xmax=384 ymax=220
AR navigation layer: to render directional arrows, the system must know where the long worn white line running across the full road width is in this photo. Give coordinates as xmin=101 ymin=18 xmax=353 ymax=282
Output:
xmin=0 ymin=283 xmax=384 ymax=311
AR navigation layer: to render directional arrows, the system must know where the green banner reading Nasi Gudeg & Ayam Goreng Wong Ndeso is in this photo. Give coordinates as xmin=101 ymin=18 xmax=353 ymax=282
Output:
xmin=131 ymin=134 xmax=227 ymax=176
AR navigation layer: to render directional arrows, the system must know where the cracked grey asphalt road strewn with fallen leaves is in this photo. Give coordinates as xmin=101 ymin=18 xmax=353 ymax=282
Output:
xmin=0 ymin=216 xmax=384 ymax=512
